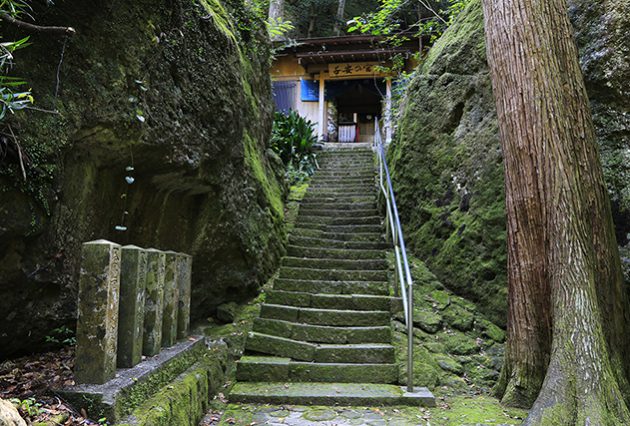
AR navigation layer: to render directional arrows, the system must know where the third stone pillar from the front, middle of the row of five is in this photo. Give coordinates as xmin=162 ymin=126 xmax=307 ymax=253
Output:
xmin=142 ymin=249 xmax=166 ymax=356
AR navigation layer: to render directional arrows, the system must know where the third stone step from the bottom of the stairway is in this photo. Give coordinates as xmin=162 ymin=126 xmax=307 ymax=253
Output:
xmin=245 ymin=331 xmax=395 ymax=364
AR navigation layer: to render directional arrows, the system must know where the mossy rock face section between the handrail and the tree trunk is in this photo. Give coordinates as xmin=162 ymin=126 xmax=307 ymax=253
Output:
xmin=390 ymin=1 xmax=507 ymax=324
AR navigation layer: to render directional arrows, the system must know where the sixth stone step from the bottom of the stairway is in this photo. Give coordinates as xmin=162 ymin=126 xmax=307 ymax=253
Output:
xmin=265 ymin=289 xmax=400 ymax=312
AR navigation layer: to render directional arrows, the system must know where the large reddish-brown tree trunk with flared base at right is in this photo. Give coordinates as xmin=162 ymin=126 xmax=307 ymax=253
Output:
xmin=484 ymin=0 xmax=630 ymax=425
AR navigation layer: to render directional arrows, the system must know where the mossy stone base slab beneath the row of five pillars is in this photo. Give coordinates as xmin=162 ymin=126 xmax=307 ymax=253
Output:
xmin=59 ymin=337 xmax=208 ymax=422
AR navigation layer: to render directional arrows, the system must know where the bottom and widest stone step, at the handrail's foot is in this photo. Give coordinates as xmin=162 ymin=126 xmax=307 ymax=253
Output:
xmin=229 ymin=382 xmax=435 ymax=407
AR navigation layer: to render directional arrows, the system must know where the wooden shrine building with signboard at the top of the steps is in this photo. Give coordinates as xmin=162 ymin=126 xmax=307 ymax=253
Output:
xmin=271 ymin=35 xmax=419 ymax=142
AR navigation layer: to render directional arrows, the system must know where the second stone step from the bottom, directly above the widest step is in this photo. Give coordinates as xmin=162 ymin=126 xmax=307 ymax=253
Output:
xmin=236 ymin=356 xmax=398 ymax=383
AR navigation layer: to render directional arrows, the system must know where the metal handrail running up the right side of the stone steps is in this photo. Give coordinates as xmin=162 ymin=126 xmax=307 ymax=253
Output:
xmin=374 ymin=119 xmax=413 ymax=392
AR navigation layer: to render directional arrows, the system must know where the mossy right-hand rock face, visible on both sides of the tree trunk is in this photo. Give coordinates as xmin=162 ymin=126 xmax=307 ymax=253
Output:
xmin=390 ymin=0 xmax=630 ymax=325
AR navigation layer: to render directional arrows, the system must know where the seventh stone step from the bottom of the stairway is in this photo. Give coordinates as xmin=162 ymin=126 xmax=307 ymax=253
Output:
xmin=273 ymin=278 xmax=389 ymax=295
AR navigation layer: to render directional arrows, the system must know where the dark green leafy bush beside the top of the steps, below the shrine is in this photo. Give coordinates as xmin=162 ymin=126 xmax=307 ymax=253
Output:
xmin=271 ymin=111 xmax=317 ymax=184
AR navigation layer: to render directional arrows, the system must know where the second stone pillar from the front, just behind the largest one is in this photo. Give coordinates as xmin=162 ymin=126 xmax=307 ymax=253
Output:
xmin=118 ymin=246 xmax=147 ymax=368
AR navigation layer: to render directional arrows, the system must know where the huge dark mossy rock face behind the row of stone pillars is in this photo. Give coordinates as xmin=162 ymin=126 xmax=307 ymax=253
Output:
xmin=0 ymin=0 xmax=285 ymax=359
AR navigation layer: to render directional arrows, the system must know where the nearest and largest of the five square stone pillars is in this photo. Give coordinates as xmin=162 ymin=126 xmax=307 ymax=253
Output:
xmin=74 ymin=240 xmax=120 ymax=384
